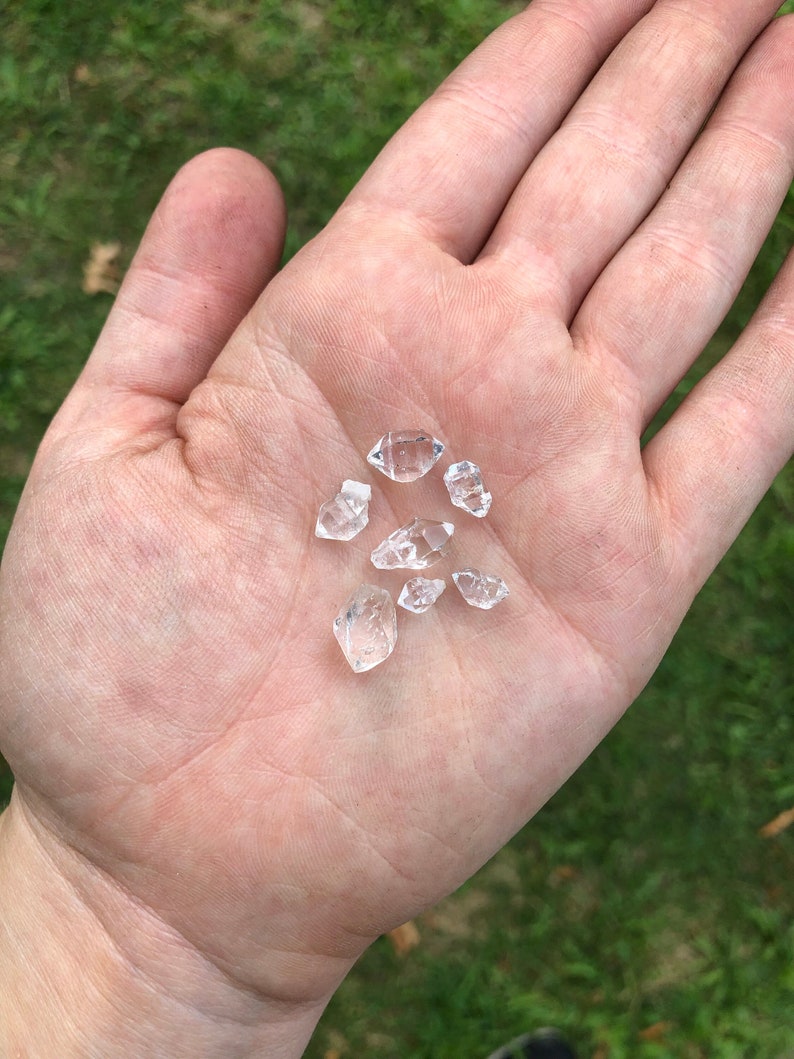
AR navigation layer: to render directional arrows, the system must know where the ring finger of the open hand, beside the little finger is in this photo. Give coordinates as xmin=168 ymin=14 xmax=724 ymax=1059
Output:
xmin=572 ymin=12 xmax=794 ymax=432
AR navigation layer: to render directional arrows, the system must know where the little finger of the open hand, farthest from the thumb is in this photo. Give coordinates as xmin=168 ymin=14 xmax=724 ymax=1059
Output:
xmin=643 ymin=252 xmax=794 ymax=595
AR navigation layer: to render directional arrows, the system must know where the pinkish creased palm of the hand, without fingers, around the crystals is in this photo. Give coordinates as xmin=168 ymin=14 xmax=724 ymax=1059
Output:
xmin=4 ymin=0 xmax=794 ymax=1008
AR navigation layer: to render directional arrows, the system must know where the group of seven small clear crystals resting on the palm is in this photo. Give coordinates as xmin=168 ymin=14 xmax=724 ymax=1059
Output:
xmin=314 ymin=430 xmax=508 ymax=672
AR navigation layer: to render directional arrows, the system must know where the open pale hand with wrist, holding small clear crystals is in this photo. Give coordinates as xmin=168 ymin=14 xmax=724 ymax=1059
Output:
xmin=0 ymin=0 xmax=794 ymax=1057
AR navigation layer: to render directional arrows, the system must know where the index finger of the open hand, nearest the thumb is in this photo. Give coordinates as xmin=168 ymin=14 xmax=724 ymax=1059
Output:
xmin=346 ymin=0 xmax=652 ymax=261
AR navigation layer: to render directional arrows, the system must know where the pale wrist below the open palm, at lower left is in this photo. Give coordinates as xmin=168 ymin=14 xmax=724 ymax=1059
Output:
xmin=0 ymin=797 xmax=342 ymax=1059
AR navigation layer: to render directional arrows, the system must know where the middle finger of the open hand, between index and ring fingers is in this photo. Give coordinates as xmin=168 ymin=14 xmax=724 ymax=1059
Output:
xmin=484 ymin=0 xmax=779 ymax=322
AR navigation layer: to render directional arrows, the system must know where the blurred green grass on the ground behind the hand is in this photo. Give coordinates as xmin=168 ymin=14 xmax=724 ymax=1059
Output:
xmin=0 ymin=0 xmax=794 ymax=1059
